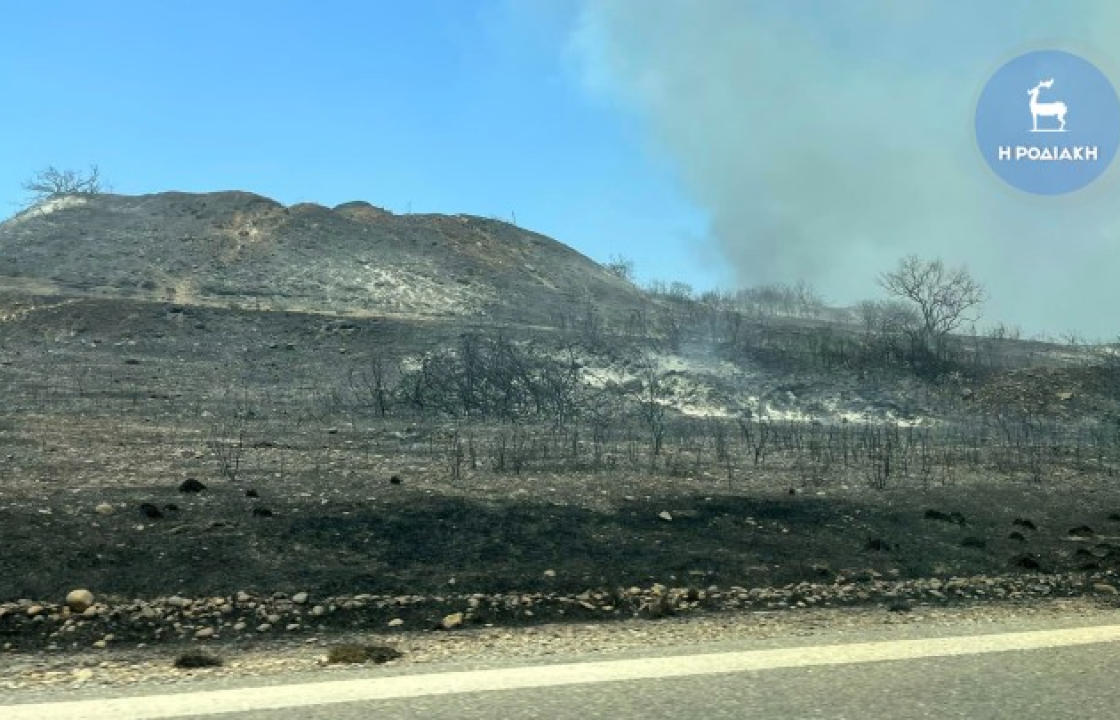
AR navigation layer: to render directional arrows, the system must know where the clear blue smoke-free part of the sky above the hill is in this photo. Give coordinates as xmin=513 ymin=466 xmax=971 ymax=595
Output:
xmin=0 ymin=0 xmax=728 ymax=287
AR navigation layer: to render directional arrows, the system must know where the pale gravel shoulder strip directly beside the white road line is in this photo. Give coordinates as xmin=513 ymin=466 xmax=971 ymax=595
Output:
xmin=0 ymin=596 xmax=1118 ymax=694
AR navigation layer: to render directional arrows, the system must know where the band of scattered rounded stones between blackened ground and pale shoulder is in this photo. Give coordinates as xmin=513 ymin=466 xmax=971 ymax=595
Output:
xmin=0 ymin=569 xmax=1120 ymax=653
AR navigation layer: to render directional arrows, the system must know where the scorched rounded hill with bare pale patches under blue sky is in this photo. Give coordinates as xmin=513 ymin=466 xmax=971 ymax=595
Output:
xmin=0 ymin=191 xmax=643 ymax=322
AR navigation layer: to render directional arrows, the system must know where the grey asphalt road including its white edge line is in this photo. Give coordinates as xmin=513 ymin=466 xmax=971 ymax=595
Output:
xmin=0 ymin=623 xmax=1120 ymax=720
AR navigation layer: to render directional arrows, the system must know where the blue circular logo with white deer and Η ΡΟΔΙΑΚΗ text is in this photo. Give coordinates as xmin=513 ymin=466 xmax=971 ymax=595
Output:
xmin=976 ymin=50 xmax=1120 ymax=195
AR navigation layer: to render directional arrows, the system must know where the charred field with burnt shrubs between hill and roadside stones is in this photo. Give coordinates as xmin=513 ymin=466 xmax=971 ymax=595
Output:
xmin=0 ymin=190 xmax=1120 ymax=631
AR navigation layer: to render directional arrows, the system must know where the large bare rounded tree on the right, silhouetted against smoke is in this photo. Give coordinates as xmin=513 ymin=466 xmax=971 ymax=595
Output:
xmin=879 ymin=255 xmax=986 ymax=356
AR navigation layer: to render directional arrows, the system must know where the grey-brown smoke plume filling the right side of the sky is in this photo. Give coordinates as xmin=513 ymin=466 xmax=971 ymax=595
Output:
xmin=571 ymin=0 xmax=1120 ymax=338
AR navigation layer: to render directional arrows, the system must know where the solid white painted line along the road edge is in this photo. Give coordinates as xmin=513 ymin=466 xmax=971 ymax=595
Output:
xmin=0 ymin=625 xmax=1120 ymax=720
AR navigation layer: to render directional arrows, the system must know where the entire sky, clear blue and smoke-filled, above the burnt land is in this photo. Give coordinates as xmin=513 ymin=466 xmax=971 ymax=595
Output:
xmin=0 ymin=0 xmax=1120 ymax=339
